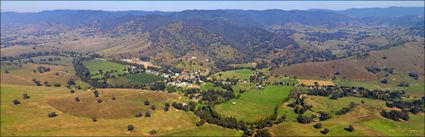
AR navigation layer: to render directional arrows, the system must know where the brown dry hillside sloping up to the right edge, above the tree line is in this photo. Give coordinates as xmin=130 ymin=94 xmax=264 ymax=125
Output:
xmin=272 ymin=42 xmax=425 ymax=96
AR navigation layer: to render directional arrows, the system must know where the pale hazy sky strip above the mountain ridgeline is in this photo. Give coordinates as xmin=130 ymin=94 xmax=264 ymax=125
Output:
xmin=1 ymin=1 xmax=424 ymax=12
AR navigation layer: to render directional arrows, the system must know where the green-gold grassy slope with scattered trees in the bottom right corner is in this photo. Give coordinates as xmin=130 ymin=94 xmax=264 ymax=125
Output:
xmin=268 ymin=96 xmax=424 ymax=136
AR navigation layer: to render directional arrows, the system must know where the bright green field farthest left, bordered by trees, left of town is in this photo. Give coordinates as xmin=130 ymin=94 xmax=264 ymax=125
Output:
xmin=83 ymin=59 xmax=127 ymax=78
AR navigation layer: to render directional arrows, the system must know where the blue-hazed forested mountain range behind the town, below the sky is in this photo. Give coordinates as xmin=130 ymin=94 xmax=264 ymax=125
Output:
xmin=1 ymin=7 xmax=424 ymax=70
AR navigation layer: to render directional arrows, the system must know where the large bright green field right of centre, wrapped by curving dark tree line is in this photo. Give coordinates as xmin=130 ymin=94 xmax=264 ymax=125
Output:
xmin=214 ymin=86 xmax=292 ymax=121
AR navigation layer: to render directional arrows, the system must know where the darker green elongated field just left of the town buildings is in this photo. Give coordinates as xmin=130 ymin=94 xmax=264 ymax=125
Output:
xmin=108 ymin=73 xmax=165 ymax=86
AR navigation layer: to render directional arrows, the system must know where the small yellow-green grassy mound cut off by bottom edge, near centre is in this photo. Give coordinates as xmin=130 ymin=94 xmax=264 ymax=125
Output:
xmin=163 ymin=125 xmax=242 ymax=137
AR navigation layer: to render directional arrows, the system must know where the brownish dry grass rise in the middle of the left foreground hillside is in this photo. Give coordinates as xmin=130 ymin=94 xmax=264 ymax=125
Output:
xmin=47 ymin=89 xmax=183 ymax=119
